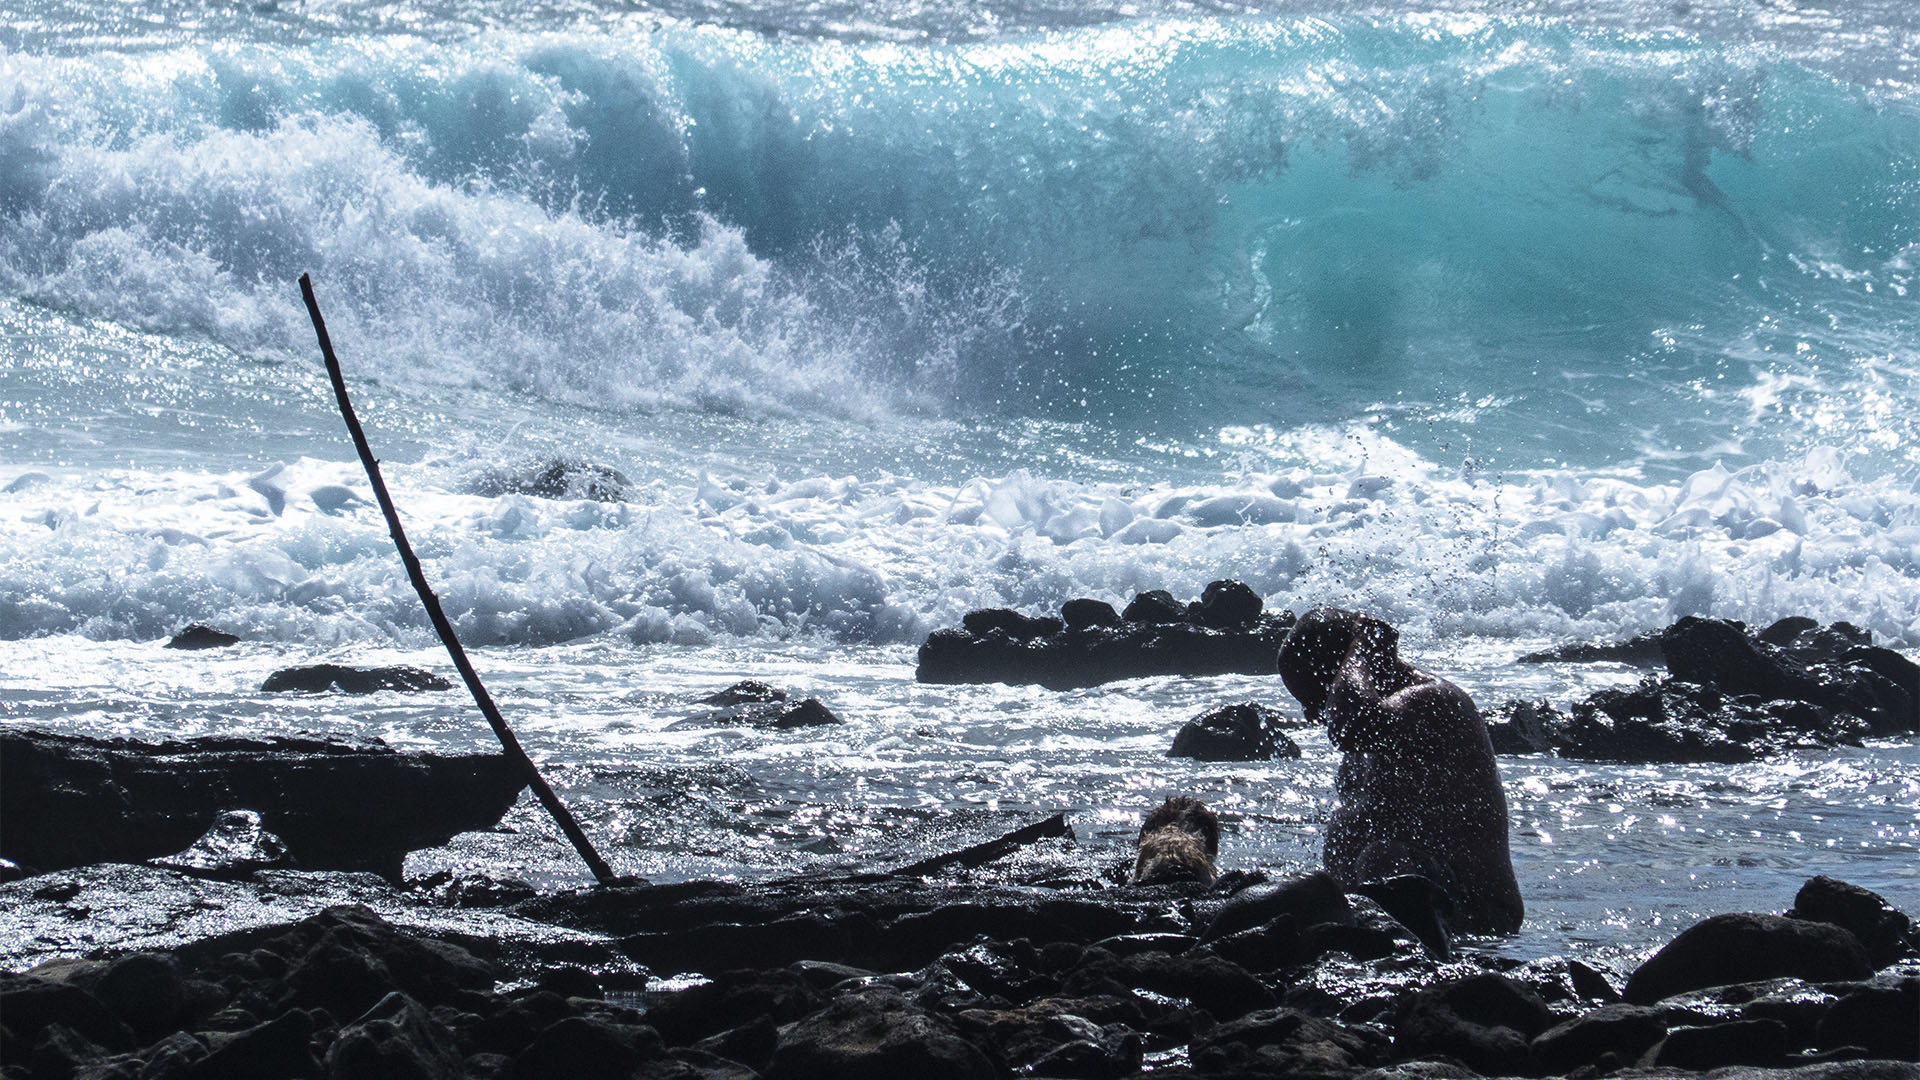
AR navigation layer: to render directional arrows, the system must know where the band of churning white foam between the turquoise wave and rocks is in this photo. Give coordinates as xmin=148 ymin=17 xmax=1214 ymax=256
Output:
xmin=0 ymin=432 xmax=1920 ymax=648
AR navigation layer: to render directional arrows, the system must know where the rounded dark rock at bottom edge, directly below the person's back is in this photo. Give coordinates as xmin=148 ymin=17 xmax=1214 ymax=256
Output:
xmin=1394 ymin=974 xmax=1553 ymax=1076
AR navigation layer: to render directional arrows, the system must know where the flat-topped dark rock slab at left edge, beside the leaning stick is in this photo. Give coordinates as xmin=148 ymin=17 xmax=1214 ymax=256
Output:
xmin=0 ymin=730 xmax=524 ymax=876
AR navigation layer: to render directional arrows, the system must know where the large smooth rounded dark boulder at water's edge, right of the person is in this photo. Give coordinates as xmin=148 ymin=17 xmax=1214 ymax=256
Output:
xmin=1624 ymin=913 xmax=1874 ymax=1005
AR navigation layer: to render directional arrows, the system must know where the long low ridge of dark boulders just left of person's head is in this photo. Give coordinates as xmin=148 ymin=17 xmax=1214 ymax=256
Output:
xmin=916 ymin=586 xmax=1292 ymax=690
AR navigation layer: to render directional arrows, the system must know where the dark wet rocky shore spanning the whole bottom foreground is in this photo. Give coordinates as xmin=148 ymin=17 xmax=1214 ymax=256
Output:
xmin=0 ymin=851 xmax=1920 ymax=1080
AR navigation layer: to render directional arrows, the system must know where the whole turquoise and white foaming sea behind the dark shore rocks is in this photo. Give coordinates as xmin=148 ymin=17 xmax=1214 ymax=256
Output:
xmin=0 ymin=0 xmax=1920 ymax=951
